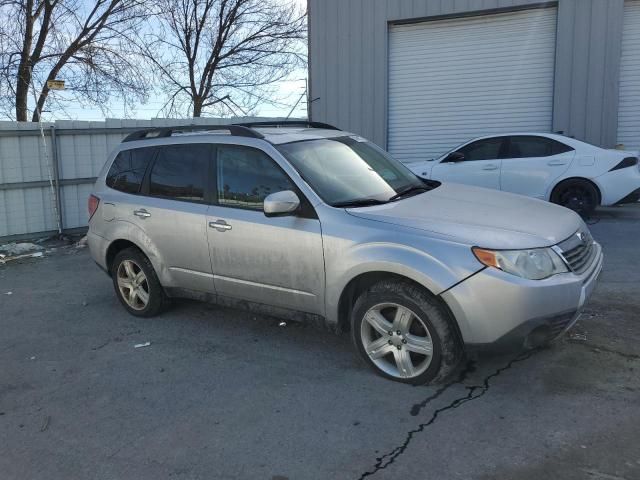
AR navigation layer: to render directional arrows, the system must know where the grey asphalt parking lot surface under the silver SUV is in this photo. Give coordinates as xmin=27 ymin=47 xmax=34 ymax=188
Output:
xmin=0 ymin=205 xmax=640 ymax=480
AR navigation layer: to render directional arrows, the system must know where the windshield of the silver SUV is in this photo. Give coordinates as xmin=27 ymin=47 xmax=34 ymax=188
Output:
xmin=277 ymin=137 xmax=432 ymax=207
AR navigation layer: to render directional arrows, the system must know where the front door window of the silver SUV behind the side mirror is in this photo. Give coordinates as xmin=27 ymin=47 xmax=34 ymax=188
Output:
xmin=218 ymin=145 xmax=294 ymax=210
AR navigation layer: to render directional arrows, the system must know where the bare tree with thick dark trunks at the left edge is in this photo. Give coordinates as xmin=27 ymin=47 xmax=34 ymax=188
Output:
xmin=0 ymin=0 xmax=148 ymax=121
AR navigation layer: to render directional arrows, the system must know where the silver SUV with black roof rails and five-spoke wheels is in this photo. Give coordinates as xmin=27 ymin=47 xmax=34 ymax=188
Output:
xmin=89 ymin=123 xmax=603 ymax=384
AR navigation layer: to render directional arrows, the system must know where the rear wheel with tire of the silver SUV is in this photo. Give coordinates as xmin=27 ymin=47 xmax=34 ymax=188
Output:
xmin=111 ymin=247 xmax=169 ymax=317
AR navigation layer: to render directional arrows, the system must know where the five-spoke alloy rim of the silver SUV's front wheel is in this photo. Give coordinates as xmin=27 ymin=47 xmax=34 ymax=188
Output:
xmin=360 ymin=303 xmax=433 ymax=379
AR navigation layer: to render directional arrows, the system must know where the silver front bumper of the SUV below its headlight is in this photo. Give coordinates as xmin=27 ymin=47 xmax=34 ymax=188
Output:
xmin=442 ymin=243 xmax=603 ymax=350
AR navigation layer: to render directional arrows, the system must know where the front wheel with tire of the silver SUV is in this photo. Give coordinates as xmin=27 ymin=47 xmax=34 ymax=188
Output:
xmin=351 ymin=280 xmax=463 ymax=385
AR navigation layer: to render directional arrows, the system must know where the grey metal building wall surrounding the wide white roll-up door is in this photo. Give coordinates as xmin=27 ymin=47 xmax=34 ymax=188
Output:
xmin=309 ymin=0 xmax=624 ymax=147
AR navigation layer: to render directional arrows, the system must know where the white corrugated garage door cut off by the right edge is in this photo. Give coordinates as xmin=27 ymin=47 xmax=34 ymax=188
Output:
xmin=618 ymin=1 xmax=640 ymax=150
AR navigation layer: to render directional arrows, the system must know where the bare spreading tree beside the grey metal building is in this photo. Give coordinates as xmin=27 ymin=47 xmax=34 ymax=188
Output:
xmin=144 ymin=0 xmax=306 ymax=117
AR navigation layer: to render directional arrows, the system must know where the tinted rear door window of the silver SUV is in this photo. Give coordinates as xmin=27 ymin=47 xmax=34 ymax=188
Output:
xmin=149 ymin=144 xmax=211 ymax=202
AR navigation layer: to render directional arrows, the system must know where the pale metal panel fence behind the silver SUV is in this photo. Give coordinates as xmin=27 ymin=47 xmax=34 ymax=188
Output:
xmin=0 ymin=118 xmax=286 ymax=237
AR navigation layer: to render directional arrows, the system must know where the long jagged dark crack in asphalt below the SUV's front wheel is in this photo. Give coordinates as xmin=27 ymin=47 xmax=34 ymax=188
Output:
xmin=358 ymin=348 xmax=542 ymax=480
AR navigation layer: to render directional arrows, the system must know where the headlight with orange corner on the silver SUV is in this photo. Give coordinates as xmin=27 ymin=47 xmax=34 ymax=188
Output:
xmin=472 ymin=247 xmax=569 ymax=280
